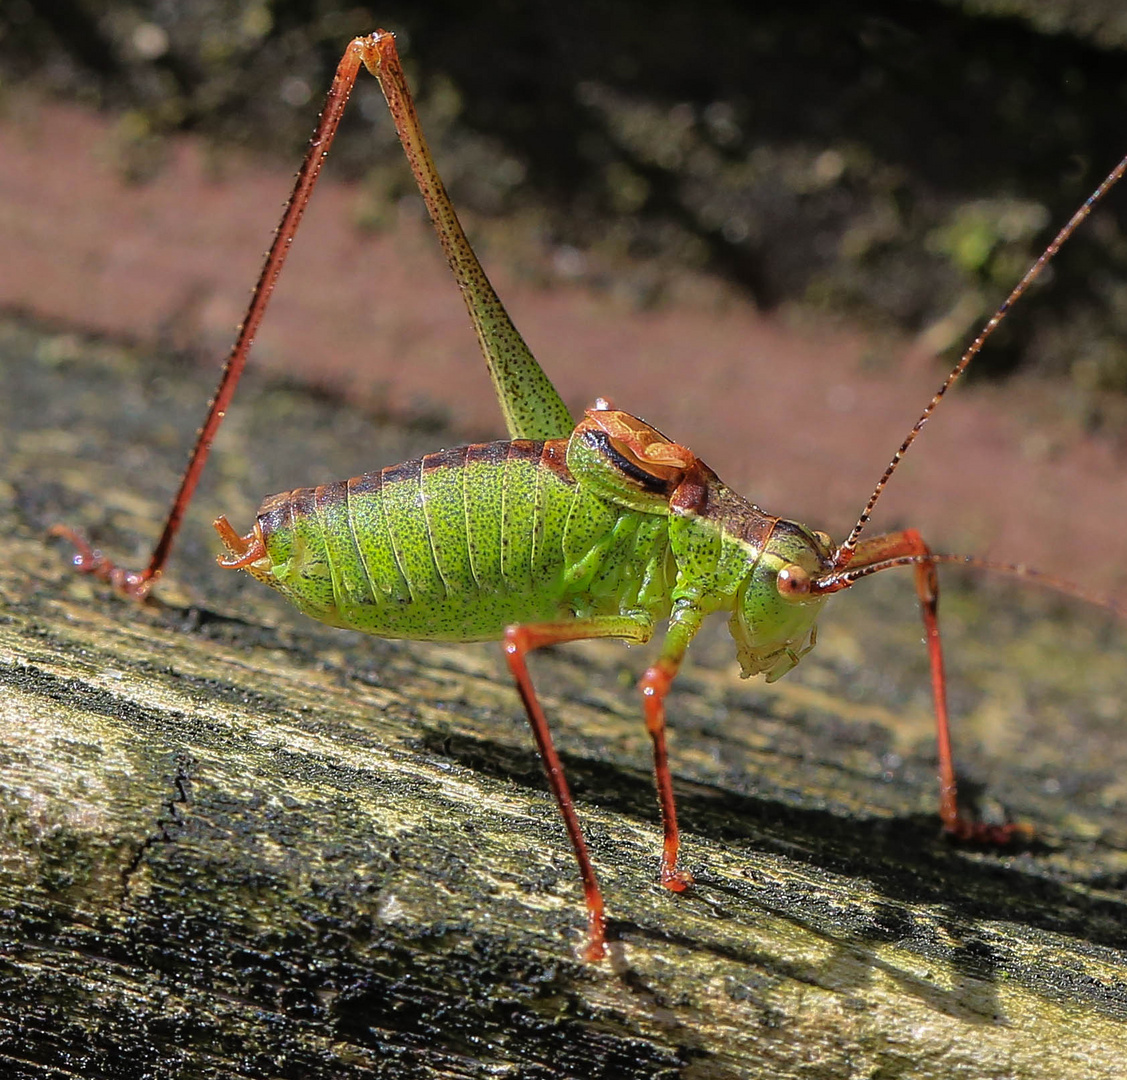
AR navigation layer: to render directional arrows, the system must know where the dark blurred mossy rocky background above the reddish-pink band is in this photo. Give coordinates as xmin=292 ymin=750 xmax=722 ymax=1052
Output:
xmin=0 ymin=0 xmax=1127 ymax=414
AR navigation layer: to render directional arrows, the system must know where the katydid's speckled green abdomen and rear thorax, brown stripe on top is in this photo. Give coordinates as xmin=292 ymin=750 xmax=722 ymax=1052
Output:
xmin=250 ymin=440 xmax=672 ymax=640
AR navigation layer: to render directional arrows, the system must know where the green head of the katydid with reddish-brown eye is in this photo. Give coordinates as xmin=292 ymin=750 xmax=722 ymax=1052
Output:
xmin=728 ymin=520 xmax=833 ymax=682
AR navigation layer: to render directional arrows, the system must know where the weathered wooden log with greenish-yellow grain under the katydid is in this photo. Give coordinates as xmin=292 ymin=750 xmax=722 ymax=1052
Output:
xmin=0 ymin=325 xmax=1127 ymax=1080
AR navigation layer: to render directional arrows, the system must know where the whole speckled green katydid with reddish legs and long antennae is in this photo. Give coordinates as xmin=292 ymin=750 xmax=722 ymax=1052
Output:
xmin=55 ymin=32 xmax=1127 ymax=959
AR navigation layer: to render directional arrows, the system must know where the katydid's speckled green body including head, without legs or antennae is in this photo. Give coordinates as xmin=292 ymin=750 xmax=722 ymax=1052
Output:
xmin=247 ymin=425 xmax=828 ymax=678
